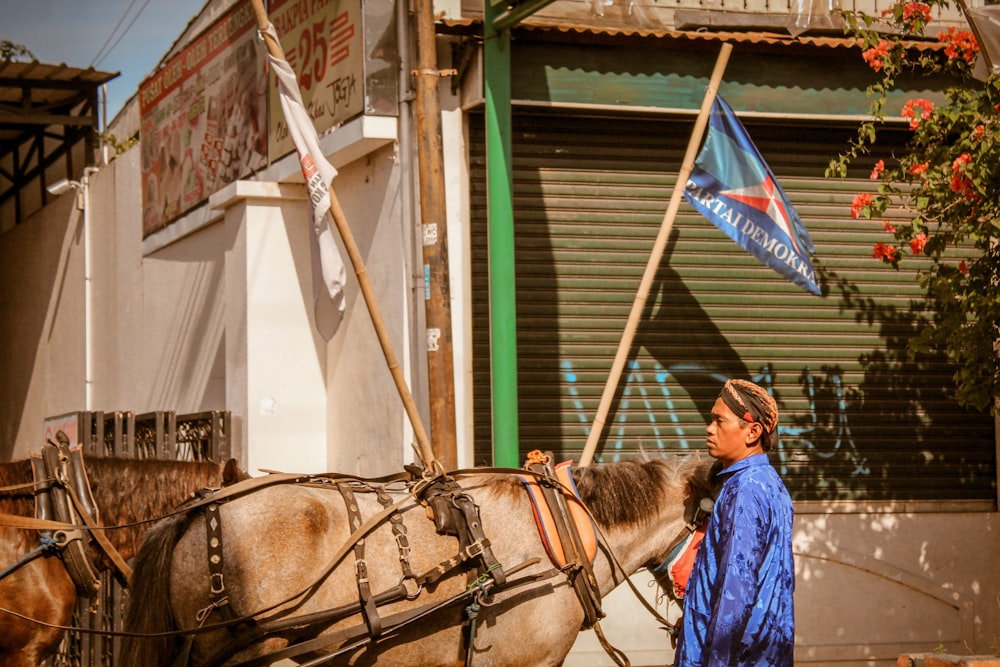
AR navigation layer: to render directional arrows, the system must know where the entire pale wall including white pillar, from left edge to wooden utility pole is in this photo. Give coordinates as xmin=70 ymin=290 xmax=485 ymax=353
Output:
xmin=0 ymin=121 xmax=421 ymax=476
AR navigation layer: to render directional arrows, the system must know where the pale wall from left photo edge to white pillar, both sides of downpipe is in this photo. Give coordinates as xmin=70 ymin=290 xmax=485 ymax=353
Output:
xmin=0 ymin=150 xmax=232 ymax=458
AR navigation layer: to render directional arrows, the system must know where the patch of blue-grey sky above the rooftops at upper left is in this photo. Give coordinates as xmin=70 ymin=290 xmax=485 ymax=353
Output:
xmin=0 ymin=0 xmax=206 ymax=119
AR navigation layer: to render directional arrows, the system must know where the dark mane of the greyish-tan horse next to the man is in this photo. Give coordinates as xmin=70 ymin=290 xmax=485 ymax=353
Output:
xmin=574 ymin=457 xmax=714 ymax=527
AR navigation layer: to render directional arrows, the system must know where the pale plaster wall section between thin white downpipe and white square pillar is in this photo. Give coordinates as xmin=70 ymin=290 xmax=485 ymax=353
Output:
xmin=95 ymin=149 xmax=226 ymax=434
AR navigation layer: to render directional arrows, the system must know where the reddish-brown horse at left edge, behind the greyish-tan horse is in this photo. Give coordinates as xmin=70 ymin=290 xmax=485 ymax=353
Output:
xmin=0 ymin=458 xmax=245 ymax=667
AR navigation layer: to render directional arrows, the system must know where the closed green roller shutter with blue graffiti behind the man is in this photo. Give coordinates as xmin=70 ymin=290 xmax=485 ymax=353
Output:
xmin=470 ymin=112 xmax=996 ymax=502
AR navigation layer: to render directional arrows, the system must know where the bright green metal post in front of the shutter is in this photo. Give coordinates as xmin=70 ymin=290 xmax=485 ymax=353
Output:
xmin=483 ymin=0 xmax=520 ymax=468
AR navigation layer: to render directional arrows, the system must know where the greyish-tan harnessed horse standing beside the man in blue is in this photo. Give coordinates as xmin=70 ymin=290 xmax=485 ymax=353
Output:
xmin=123 ymin=457 xmax=712 ymax=667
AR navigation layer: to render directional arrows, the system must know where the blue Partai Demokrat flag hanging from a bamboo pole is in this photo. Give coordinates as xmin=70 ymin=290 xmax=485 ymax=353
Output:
xmin=684 ymin=95 xmax=820 ymax=294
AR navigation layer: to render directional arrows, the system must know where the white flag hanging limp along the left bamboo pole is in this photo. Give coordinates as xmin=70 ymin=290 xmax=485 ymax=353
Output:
xmin=267 ymin=24 xmax=347 ymax=340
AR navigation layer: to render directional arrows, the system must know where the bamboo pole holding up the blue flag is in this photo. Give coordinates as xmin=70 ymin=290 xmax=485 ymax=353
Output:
xmin=579 ymin=44 xmax=733 ymax=467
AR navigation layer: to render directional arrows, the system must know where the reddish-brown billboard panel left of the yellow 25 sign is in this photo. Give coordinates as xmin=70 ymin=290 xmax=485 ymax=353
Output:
xmin=139 ymin=0 xmax=267 ymax=237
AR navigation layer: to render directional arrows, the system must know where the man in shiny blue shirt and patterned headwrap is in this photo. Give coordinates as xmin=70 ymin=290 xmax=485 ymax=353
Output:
xmin=674 ymin=380 xmax=795 ymax=667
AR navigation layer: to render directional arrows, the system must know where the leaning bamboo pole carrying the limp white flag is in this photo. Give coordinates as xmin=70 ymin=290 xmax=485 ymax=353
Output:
xmin=253 ymin=0 xmax=443 ymax=472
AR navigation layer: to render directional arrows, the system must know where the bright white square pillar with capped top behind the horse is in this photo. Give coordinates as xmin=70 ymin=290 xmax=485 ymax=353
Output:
xmin=218 ymin=182 xmax=327 ymax=474
